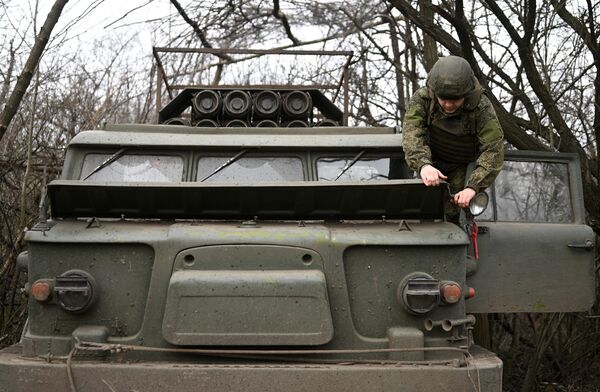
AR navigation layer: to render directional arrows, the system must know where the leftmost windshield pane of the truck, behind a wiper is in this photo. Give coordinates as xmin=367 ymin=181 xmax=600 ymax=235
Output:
xmin=79 ymin=154 xmax=183 ymax=182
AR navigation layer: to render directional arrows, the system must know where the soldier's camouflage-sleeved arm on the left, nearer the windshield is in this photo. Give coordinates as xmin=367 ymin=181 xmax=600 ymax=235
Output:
xmin=402 ymin=88 xmax=431 ymax=173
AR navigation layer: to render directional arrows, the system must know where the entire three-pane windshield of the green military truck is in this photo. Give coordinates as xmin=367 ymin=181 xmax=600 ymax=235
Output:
xmin=79 ymin=149 xmax=406 ymax=183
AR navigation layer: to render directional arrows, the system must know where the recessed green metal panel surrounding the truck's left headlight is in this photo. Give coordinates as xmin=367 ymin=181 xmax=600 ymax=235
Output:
xmin=27 ymin=242 xmax=154 ymax=337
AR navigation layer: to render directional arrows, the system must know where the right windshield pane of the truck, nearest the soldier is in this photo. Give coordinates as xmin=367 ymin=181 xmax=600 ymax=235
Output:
xmin=317 ymin=156 xmax=390 ymax=181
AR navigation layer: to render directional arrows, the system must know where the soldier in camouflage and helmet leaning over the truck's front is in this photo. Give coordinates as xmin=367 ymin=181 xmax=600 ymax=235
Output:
xmin=402 ymin=56 xmax=504 ymax=221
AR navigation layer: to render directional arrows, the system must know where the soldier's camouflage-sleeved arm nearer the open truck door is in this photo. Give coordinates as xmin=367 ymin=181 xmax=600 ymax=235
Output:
xmin=467 ymin=96 xmax=504 ymax=192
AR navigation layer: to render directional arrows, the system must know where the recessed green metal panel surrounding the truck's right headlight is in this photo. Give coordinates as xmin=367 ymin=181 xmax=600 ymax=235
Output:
xmin=344 ymin=245 xmax=465 ymax=338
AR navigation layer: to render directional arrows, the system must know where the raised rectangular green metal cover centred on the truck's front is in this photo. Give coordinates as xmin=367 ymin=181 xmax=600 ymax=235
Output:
xmin=162 ymin=270 xmax=333 ymax=346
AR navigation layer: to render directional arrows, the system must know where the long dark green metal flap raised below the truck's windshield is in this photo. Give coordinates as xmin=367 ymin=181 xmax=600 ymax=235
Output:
xmin=48 ymin=180 xmax=448 ymax=220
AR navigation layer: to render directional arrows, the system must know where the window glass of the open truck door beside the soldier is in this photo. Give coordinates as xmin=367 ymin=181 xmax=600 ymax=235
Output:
xmin=495 ymin=162 xmax=573 ymax=223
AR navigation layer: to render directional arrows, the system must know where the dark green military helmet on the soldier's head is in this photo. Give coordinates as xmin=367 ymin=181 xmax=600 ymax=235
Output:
xmin=427 ymin=56 xmax=475 ymax=99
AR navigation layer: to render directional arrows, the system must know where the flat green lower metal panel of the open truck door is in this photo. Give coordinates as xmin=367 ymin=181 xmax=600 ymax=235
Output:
xmin=467 ymin=222 xmax=596 ymax=313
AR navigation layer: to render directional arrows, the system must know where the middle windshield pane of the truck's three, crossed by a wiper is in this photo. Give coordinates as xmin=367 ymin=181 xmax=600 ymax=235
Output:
xmin=196 ymin=156 xmax=304 ymax=183
